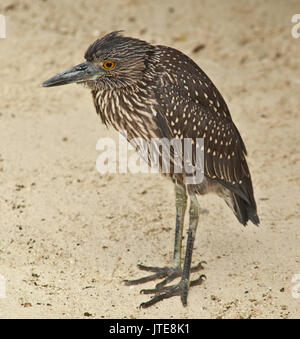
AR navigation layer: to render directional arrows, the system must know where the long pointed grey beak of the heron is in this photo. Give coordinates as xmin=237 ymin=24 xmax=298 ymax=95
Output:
xmin=42 ymin=61 xmax=102 ymax=87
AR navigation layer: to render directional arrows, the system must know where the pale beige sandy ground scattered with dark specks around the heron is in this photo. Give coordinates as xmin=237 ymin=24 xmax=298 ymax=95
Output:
xmin=0 ymin=0 xmax=300 ymax=318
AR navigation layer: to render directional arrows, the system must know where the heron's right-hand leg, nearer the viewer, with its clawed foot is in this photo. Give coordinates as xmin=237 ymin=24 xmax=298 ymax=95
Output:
xmin=141 ymin=194 xmax=205 ymax=308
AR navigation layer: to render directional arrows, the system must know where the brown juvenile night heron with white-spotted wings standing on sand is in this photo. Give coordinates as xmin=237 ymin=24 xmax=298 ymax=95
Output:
xmin=43 ymin=32 xmax=259 ymax=307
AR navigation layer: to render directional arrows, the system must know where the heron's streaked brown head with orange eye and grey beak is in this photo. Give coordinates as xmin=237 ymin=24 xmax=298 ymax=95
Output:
xmin=43 ymin=31 xmax=155 ymax=89
